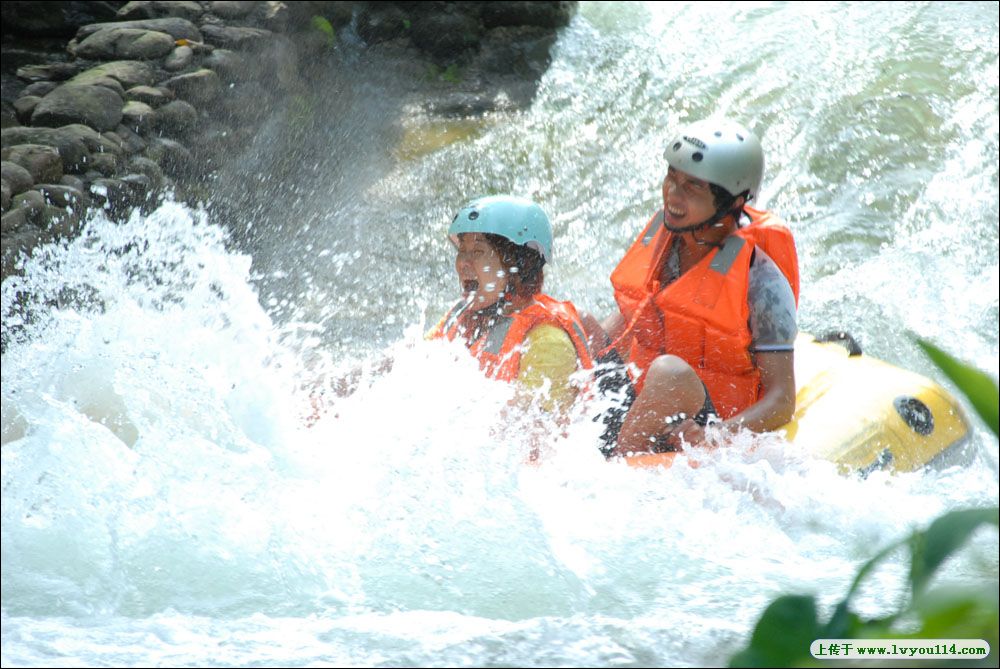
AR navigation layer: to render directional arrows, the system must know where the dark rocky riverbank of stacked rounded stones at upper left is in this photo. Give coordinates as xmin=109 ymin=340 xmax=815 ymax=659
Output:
xmin=2 ymin=1 xmax=575 ymax=277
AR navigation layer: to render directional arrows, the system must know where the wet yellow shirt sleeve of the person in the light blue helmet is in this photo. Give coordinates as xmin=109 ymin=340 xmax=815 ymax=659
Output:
xmin=517 ymin=324 xmax=577 ymax=411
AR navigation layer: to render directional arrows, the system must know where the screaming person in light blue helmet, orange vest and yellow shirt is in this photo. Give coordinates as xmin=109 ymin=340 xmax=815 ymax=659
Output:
xmin=428 ymin=195 xmax=593 ymax=409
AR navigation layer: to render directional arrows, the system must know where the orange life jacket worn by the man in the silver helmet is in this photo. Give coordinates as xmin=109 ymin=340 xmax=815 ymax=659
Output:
xmin=611 ymin=207 xmax=799 ymax=418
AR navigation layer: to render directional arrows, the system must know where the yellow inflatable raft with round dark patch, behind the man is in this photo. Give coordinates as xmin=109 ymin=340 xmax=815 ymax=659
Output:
xmin=626 ymin=333 xmax=970 ymax=475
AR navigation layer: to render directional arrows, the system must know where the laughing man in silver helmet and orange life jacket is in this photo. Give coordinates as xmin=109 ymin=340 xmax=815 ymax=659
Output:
xmin=588 ymin=119 xmax=799 ymax=455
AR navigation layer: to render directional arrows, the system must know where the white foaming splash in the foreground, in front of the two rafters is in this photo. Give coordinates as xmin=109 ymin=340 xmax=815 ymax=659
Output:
xmin=3 ymin=203 xmax=997 ymax=664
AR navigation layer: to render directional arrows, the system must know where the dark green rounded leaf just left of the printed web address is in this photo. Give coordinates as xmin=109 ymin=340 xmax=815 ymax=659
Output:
xmin=729 ymin=595 xmax=821 ymax=667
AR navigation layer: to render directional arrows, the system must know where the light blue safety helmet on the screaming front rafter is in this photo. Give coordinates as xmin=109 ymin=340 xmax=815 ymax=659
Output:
xmin=448 ymin=195 xmax=552 ymax=263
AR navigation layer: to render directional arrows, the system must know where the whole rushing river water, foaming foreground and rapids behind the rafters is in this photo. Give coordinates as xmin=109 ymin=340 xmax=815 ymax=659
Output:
xmin=2 ymin=3 xmax=1000 ymax=666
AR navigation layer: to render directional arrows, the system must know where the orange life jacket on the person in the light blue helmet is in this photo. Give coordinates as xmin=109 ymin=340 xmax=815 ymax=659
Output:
xmin=430 ymin=293 xmax=594 ymax=381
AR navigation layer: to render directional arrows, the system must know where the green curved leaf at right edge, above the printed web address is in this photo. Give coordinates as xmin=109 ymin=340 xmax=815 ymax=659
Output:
xmin=910 ymin=507 xmax=1000 ymax=595
